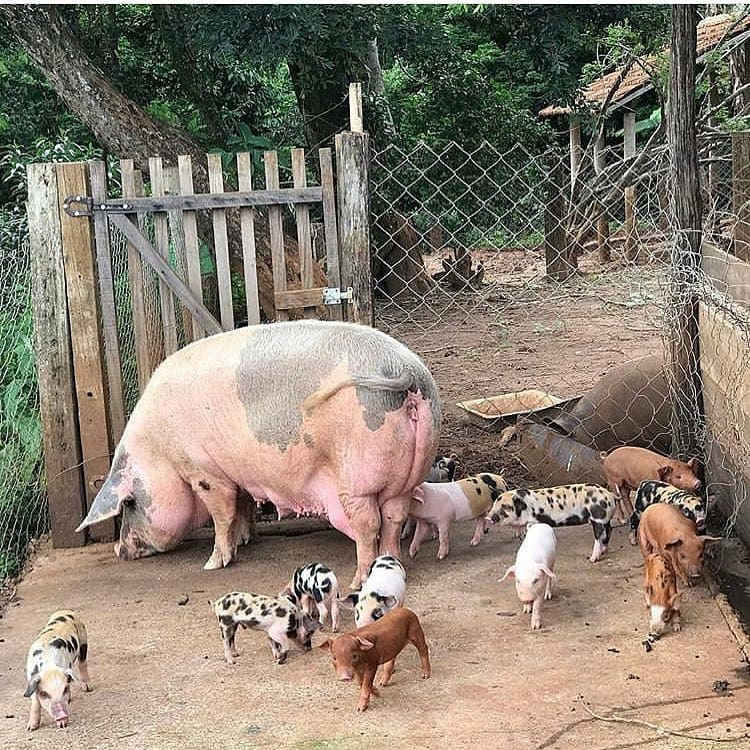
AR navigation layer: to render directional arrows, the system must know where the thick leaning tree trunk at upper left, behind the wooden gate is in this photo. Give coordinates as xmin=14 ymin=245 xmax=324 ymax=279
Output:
xmin=0 ymin=5 xmax=325 ymax=320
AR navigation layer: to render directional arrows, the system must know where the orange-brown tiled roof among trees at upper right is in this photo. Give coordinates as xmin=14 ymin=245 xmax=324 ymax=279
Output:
xmin=539 ymin=14 xmax=750 ymax=117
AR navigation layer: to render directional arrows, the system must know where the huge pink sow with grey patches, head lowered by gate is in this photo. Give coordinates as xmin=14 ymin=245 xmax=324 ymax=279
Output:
xmin=78 ymin=320 xmax=441 ymax=588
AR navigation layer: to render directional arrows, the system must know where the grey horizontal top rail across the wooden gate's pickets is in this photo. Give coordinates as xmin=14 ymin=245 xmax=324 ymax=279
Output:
xmin=83 ymin=186 xmax=321 ymax=214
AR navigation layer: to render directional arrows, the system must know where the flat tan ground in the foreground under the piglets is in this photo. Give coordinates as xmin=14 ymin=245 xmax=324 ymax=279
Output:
xmin=0 ymin=523 xmax=750 ymax=750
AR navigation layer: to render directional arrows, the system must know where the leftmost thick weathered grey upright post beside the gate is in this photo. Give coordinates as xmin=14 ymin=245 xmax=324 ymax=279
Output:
xmin=26 ymin=164 xmax=86 ymax=547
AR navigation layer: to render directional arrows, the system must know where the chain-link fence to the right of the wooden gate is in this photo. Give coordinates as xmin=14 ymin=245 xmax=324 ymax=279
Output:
xmin=372 ymin=128 xmax=750 ymax=530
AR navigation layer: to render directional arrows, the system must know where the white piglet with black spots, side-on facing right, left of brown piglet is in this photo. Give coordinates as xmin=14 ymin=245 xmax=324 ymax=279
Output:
xmin=214 ymin=591 xmax=318 ymax=664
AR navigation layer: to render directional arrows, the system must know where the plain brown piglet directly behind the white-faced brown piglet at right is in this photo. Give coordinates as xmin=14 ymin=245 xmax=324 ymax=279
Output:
xmin=638 ymin=503 xmax=721 ymax=586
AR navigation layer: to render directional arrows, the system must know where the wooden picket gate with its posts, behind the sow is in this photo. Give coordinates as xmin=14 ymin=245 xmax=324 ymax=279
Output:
xmin=28 ymin=133 xmax=373 ymax=546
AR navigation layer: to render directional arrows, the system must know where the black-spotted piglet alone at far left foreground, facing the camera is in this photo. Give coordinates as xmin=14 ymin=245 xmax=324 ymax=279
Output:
xmin=24 ymin=609 xmax=91 ymax=731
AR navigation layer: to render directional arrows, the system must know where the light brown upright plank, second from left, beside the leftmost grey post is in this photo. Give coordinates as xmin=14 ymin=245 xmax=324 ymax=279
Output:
xmin=55 ymin=162 xmax=115 ymax=541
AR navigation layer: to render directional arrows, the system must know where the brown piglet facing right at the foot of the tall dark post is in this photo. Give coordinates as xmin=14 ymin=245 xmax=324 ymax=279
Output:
xmin=601 ymin=445 xmax=701 ymax=518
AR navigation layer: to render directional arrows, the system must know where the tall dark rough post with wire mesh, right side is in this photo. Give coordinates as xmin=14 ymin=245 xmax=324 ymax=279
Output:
xmin=666 ymin=5 xmax=703 ymax=458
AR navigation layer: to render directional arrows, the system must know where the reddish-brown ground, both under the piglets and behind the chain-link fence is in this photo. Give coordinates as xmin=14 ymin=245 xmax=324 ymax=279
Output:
xmin=0 ymin=258 xmax=750 ymax=750
